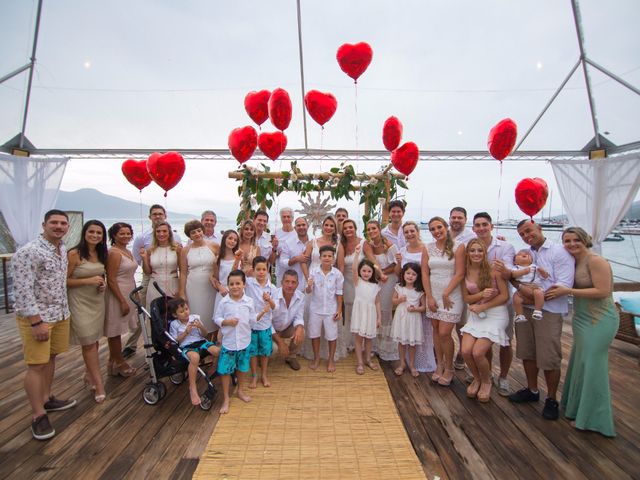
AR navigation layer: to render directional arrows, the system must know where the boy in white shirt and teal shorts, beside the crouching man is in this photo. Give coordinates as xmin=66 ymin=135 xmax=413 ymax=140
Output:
xmin=245 ymin=255 xmax=276 ymax=388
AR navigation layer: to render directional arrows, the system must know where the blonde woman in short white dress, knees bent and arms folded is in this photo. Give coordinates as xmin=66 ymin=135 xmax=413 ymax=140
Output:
xmin=461 ymin=238 xmax=509 ymax=402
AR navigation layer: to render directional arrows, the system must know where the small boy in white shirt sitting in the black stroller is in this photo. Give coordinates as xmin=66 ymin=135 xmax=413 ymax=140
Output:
xmin=167 ymin=298 xmax=220 ymax=405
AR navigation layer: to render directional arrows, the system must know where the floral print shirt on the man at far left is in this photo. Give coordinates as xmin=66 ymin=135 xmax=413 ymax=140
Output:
xmin=11 ymin=236 xmax=69 ymax=322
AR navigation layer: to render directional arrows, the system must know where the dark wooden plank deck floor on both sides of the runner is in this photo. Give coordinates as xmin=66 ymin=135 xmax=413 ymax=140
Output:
xmin=0 ymin=315 xmax=640 ymax=480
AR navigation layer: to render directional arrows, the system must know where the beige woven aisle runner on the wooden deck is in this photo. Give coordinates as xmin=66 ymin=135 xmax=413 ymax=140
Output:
xmin=193 ymin=355 xmax=425 ymax=480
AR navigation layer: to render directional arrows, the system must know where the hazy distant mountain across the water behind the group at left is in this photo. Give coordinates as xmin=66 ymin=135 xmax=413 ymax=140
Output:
xmin=55 ymin=188 xmax=199 ymax=220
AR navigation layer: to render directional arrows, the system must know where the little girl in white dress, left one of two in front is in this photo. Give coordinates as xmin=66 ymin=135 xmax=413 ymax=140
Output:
xmin=351 ymin=245 xmax=382 ymax=375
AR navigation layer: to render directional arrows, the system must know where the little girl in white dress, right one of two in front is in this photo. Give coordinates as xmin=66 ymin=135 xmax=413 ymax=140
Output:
xmin=391 ymin=262 xmax=427 ymax=377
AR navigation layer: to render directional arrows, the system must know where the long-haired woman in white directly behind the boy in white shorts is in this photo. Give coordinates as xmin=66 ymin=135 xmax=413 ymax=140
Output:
xmin=300 ymin=215 xmax=347 ymax=361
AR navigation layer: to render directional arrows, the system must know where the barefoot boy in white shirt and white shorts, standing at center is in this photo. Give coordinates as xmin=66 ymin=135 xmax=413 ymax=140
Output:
xmin=306 ymin=245 xmax=344 ymax=373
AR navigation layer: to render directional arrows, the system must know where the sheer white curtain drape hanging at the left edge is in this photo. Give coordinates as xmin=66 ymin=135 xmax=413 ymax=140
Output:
xmin=0 ymin=154 xmax=69 ymax=246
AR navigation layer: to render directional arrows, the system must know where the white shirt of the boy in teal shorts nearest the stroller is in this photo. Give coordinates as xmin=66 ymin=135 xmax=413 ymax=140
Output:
xmin=214 ymin=294 xmax=257 ymax=351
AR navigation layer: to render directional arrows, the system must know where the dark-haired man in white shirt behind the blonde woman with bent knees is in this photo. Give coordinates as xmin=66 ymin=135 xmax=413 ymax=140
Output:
xmin=473 ymin=212 xmax=516 ymax=397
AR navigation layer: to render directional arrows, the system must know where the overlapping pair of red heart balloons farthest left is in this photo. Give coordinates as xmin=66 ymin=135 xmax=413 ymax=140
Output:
xmin=122 ymin=152 xmax=185 ymax=197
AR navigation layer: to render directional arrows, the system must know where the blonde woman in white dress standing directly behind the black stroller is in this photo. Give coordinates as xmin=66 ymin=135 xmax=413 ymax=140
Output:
xmin=140 ymin=222 xmax=182 ymax=309
